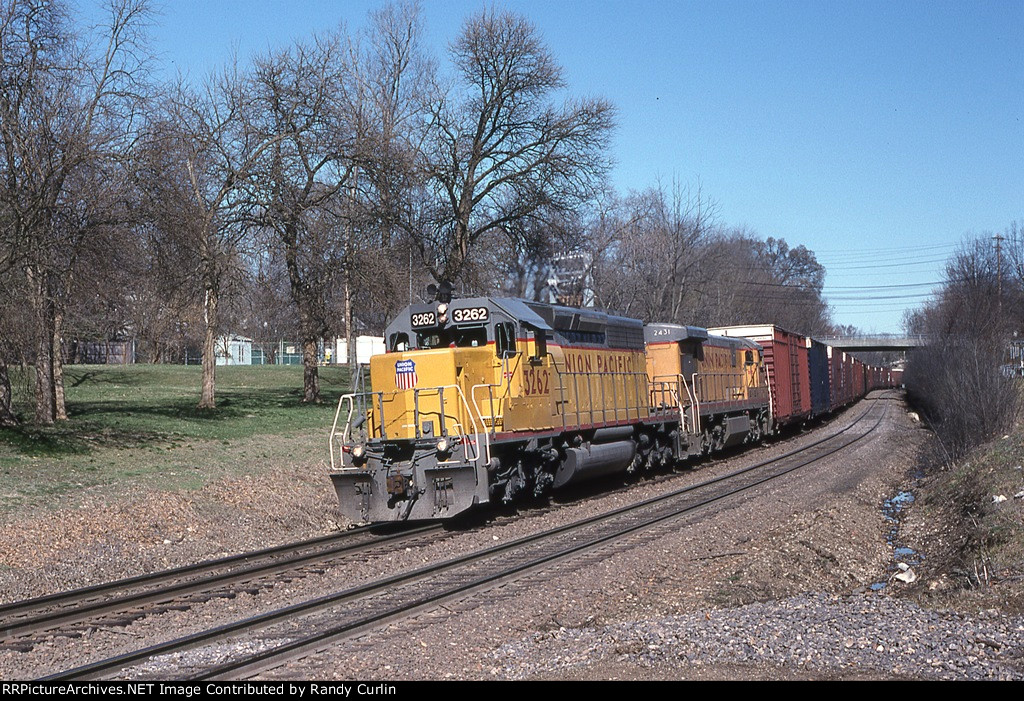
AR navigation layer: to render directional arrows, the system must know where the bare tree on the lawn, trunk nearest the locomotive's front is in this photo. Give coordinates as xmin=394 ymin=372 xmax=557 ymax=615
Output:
xmin=247 ymin=33 xmax=361 ymax=402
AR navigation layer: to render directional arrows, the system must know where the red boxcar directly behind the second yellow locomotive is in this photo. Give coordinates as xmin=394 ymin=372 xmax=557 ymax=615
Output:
xmin=708 ymin=324 xmax=811 ymax=426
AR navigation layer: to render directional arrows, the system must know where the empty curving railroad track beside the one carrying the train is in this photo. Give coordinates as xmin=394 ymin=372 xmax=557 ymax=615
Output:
xmin=41 ymin=390 xmax=888 ymax=680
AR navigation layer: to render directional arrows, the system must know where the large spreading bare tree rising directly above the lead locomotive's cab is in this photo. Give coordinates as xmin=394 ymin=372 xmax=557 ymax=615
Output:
xmin=402 ymin=9 xmax=613 ymax=280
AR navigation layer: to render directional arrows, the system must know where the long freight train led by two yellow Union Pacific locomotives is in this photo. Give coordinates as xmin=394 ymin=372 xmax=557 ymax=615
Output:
xmin=330 ymin=294 xmax=893 ymax=522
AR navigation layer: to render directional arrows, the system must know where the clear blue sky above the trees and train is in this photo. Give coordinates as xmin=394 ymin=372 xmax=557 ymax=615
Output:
xmin=105 ymin=0 xmax=1024 ymax=332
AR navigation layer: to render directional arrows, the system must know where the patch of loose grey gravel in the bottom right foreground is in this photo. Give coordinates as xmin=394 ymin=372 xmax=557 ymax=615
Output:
xmin=492 ymin=594 xmax=1024 ymax=680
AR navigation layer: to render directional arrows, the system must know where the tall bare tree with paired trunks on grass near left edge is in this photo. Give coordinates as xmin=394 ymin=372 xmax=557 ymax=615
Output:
xmin=0 ymin=0 xmax=147 ymax=424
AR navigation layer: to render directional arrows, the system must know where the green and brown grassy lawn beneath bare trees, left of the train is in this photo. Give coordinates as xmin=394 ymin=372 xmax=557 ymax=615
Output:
xmin=0 ymin=365 xmax=349 ymax=511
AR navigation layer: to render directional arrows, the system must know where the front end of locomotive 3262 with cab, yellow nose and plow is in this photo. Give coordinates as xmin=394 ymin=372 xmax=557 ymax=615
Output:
xmin=331 ymin=298 xmax=552 ymax=521
